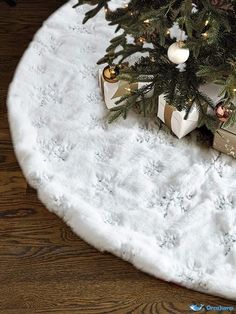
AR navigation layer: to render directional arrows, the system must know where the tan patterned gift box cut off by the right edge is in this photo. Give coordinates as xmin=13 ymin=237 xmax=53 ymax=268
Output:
xmin=213 ymin=123 xmax=236 ymax=158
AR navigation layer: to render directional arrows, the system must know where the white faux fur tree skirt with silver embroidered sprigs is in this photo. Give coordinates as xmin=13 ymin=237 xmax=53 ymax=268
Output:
xmin=8 ymin=2 xmax=236 ymax=300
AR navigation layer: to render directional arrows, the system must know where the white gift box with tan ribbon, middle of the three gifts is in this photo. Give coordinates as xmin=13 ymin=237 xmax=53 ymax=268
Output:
xmin=157 ymin=95 xmax=199 ymax=138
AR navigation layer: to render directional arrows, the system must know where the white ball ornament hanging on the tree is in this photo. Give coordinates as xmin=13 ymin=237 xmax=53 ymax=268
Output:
xmin=167 ymin=42 xmax=189 ymax=64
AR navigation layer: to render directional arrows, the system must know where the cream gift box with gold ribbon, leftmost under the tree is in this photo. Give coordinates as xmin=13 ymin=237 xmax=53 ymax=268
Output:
xmin=98 ymin=69 xmax=152 ymax=109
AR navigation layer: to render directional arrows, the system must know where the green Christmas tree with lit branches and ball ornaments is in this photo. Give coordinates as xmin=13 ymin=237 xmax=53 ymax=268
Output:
xmin=76 ymin=0 xmax=236 ymax=128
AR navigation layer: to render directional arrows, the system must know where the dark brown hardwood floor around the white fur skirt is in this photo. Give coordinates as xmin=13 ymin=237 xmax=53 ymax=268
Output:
xmin=0 ymin=0 xmax=236 ymax=314
